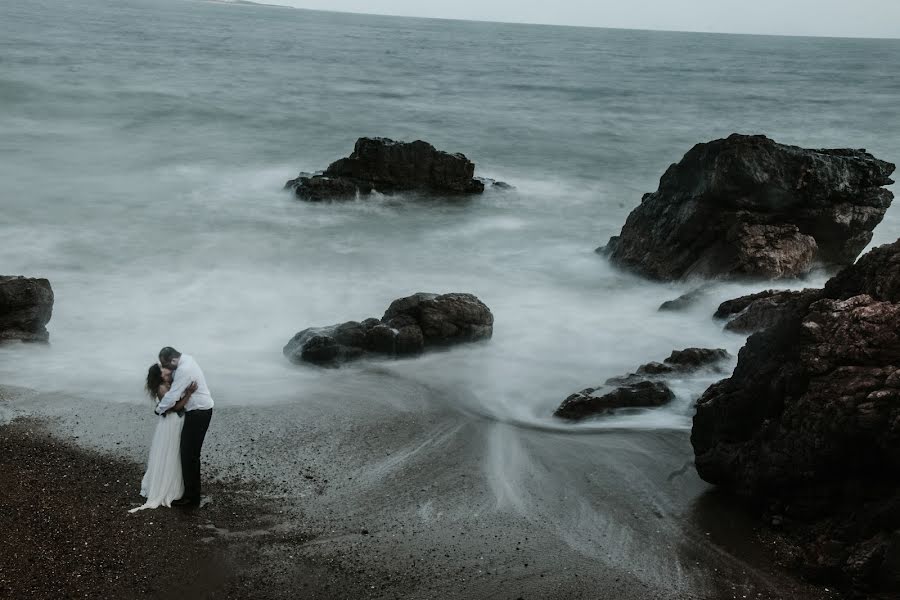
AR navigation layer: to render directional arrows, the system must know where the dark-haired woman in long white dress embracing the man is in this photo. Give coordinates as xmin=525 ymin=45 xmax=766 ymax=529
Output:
xmin=128 ymin=364 xmax=197 ymax=513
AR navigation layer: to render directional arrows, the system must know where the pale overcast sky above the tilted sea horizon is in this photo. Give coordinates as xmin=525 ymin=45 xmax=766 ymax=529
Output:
xmin=268 ymin=0 xmax=900 ymax=38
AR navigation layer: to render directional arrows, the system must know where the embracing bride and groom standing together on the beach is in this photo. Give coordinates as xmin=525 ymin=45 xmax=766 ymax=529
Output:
xmin=129 ymin=346 xmax=213 ymax=512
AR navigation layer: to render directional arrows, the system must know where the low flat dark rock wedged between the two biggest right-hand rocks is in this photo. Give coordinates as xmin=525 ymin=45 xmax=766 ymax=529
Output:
xmin=713 ymin=289 xmax=822 ymax=333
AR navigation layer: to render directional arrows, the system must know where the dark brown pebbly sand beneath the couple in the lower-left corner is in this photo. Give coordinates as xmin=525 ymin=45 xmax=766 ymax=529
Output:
xmin=0 ymin=418 xmax=422 ymax=599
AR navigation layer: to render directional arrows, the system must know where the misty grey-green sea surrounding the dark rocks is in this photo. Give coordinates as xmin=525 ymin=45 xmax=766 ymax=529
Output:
xmin=0 ymin=0 xmax=900 ymax=428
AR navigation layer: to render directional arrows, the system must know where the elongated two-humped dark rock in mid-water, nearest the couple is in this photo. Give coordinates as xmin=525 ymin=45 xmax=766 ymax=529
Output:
xmin=283 ymin=293 xmax=494 ymax=366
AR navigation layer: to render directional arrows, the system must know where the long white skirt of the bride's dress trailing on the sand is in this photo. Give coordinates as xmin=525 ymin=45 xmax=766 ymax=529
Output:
xmin=128 ymin=413 xmax=184 ymax=513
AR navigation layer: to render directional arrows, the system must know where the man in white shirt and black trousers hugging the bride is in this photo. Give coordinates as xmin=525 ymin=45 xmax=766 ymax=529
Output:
xmin=156 ymin=346 xmax=213 ymax=508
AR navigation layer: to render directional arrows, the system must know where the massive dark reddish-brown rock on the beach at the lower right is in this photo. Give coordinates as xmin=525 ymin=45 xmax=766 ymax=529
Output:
xmin=691 ymin=240 xmax=900 ymax=590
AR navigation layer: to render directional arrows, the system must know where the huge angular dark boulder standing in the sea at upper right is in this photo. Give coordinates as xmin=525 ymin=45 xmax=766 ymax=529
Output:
xmin=602 ymin=134 xmax=895 ymax=280
